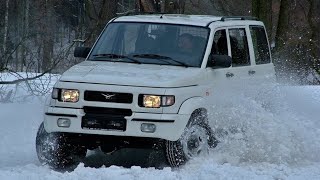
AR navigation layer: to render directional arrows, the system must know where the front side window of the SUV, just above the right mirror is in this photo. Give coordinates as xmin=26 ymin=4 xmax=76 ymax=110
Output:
xmin=211 ymin=29 xmax=228 ymax=55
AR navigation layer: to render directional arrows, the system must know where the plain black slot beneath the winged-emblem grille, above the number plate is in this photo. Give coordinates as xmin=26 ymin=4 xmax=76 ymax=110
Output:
xmin=83 ymin=106 xmax=132 ymax=117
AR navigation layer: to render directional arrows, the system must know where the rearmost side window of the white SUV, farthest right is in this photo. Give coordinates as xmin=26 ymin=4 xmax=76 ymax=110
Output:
xmin=250 ymin=26 xmax=271 ymax=64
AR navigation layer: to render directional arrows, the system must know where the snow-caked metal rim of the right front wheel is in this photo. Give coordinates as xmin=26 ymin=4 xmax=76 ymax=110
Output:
xmin=181 ymin=125 xmax=209 ymax=159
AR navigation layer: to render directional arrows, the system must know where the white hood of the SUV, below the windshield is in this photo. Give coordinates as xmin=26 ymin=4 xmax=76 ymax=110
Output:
xmin=60 ymin=61 xmax=205 ymax=87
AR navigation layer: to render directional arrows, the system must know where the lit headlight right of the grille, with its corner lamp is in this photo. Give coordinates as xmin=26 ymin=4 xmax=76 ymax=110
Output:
xmin=140 ymin=95 xmax=175 ymax=108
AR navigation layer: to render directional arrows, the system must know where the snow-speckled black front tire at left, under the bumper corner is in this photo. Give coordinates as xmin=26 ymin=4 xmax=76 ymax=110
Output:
xmin=36 ymin=123 xmax=87 ymax=170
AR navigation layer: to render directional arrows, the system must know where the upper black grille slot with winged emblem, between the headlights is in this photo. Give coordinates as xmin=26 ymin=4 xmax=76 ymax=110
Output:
xmin=84 ymin=91 xmax=133 ymax=104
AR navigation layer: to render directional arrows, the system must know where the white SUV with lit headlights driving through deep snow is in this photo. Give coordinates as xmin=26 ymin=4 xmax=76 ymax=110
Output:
xmin=36 ymin=14 xmax=275 ymax=168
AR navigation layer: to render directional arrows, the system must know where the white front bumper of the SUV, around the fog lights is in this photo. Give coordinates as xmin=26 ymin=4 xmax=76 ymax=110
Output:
xmin=44 ymin=106 xmax=190 ymax=141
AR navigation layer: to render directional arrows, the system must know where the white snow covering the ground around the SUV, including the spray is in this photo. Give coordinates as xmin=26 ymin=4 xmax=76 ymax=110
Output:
xmin=0 ymin=73 xmax=320 ymax=180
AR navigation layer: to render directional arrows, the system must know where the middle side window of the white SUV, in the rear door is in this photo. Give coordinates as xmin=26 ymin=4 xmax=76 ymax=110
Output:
xmin=229 ymin=28 xmax=250 ymax=66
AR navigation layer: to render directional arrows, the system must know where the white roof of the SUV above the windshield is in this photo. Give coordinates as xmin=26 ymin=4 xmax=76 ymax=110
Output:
xmin=114 ymin=14 xmax=222 ymax=27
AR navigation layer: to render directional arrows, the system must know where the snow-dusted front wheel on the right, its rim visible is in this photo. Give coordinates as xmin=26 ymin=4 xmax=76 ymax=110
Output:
xmin=165 ymin=111 xmax=218 ymax=167
